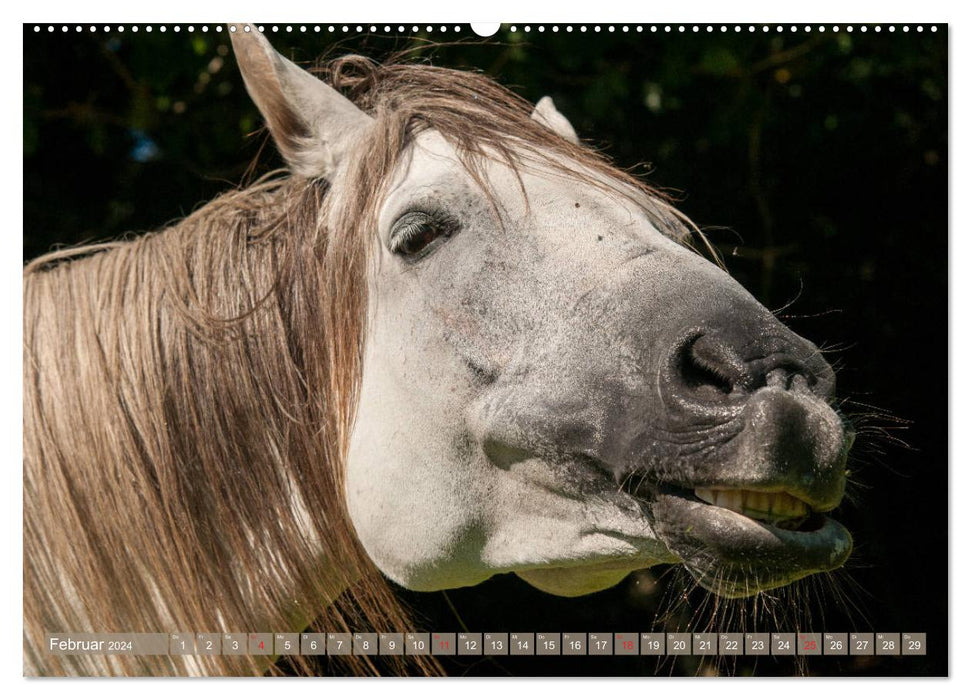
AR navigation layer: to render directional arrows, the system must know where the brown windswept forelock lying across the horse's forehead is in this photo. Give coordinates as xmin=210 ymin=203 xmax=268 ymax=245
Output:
xmin=311 ymin=53 xmax=718 ymax=250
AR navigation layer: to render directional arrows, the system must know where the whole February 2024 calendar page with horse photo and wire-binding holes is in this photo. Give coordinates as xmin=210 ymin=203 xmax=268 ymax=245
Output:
xmin=22 ymin=20 xmax=950 ymax=677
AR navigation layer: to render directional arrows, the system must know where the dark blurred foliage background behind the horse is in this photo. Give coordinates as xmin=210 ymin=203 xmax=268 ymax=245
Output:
xmin=24 ymin=25 xmax=948 ymax=675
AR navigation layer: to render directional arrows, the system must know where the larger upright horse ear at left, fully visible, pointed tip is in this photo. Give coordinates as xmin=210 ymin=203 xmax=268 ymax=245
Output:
xmin=229 ymin=24 xmax=373 ymax=178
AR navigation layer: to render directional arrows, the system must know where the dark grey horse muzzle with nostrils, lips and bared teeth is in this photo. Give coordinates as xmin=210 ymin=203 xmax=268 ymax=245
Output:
xmin=642 ymin=330 xmax=853 ymax=597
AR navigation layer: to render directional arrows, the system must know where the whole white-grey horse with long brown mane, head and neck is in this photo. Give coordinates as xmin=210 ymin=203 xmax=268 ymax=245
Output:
xmin=23 ymin=25 xmax=853 ymax=675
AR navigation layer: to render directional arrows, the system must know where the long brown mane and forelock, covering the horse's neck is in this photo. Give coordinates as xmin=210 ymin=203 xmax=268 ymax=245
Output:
xmin=24 ymin=49 xmax=700 ymax=675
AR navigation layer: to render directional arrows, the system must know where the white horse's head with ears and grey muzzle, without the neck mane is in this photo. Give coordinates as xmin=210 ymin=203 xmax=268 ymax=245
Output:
xmin=233 ymin=30 xmax=852 ymax=596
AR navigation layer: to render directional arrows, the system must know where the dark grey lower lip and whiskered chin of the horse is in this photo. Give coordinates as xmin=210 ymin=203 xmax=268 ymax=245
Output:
xmin=652 ymin=492 xmax=853 ymax=598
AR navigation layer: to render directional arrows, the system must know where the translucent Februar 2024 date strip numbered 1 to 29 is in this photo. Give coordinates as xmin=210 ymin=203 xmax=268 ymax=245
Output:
xmin=47 ymin=632 xmax=927 ymax=656
